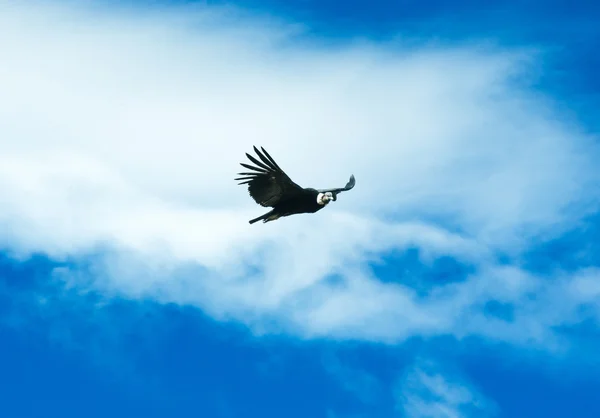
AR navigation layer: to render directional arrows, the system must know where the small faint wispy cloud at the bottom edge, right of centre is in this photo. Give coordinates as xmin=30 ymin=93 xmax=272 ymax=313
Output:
xmin=396 ymin=360 xmax=498 ymax=418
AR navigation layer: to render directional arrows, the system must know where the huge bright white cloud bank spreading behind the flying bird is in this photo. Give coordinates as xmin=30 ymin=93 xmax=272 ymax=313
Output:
xmin=0 ymin=1 xmax=600 ymax=341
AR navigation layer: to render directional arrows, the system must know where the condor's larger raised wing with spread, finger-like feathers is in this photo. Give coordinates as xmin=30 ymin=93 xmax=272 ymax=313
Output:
xmin=235 ymin=146 xmax=304 ymax=207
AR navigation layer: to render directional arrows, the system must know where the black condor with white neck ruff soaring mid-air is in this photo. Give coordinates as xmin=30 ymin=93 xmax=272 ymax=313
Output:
xmin=235 ymin=147 xmax=356 ymax=224
